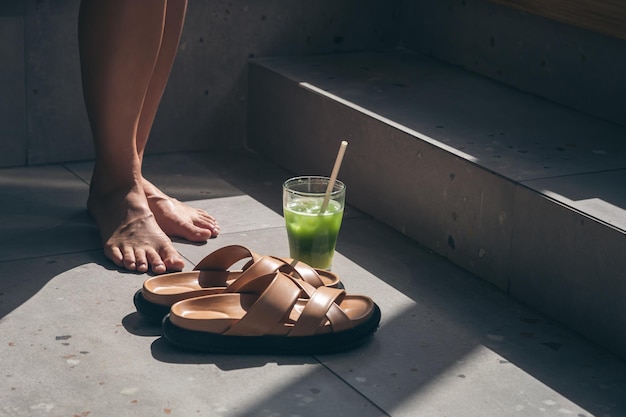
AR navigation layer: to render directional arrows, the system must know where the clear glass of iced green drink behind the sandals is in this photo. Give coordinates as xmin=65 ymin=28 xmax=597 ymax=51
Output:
xmin=283 ymin=176 xmax=346 ymax=270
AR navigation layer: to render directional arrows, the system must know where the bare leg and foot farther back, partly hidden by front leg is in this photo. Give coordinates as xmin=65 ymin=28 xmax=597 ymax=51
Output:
xmin=137 ymin=0 xmax=220 ymax=242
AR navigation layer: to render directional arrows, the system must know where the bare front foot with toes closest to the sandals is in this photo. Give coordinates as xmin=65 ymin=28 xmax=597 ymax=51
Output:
xmin=87 ymin=179 xmax=185 ymax=274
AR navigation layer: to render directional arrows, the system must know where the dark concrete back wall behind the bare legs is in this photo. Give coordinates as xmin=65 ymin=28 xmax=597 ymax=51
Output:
xmin=0 ymin=0 xmax=398 ymax=167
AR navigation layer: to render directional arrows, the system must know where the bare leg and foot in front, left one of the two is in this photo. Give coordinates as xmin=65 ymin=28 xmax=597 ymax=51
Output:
xmin=79 ymin=0 xmax=184 ymax=273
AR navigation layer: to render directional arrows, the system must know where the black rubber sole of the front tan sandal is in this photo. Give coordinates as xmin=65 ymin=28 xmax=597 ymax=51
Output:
xmin=161 ymin=304 xmax=381 ymax=355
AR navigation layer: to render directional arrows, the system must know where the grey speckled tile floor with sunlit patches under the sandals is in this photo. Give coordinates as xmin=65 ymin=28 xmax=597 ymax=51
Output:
xmin=0 ymin=153 xmax=626 ymax=417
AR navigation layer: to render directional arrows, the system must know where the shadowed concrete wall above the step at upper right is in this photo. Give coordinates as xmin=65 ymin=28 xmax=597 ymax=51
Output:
xmin=401 ymin=0 xmax=626 ymax=125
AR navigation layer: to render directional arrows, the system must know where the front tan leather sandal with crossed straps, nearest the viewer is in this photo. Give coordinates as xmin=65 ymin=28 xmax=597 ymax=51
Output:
xmin=162 ymin=272 xmax=380 ymax=354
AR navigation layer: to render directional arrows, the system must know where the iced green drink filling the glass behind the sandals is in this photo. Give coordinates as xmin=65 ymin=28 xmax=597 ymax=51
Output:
xmin=284 ymin=198 xmax=343 ymax=269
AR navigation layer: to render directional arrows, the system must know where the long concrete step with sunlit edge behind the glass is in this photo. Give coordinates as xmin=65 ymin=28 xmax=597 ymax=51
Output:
xmin=248 ymin=53 xmax=626 ymax=357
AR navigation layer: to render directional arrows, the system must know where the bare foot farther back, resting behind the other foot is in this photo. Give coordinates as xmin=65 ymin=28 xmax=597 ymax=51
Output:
xmin=143 ymin=178 xmax=220 ymax=242
